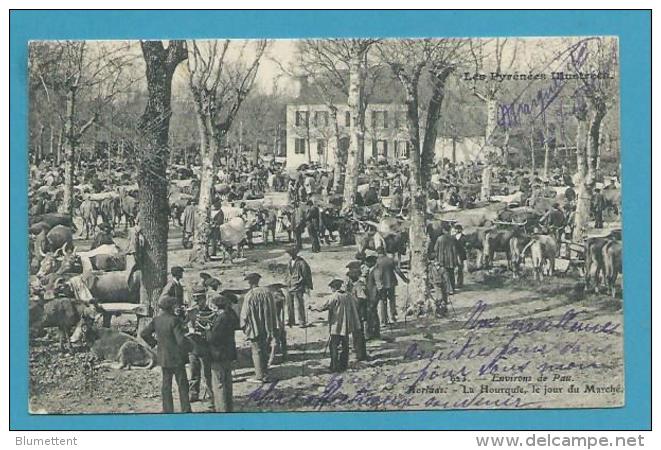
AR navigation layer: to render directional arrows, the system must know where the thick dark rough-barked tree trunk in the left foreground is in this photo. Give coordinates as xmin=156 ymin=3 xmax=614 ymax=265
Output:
xmin=138 ymin=41 xmax=187 ymax=318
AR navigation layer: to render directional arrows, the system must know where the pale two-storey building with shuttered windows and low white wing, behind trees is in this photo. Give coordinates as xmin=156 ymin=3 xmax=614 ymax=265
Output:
xmin=286 ymin=76 xmax=484 ymax=167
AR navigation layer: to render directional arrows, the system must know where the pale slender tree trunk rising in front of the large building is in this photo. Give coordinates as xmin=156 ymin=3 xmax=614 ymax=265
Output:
xmin=344 ymin=52 xmax=364 ymax=206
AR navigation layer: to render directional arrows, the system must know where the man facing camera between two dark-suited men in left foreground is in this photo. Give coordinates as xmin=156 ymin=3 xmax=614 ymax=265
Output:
xmin=186 ymin=285 xmax=214 ymax=403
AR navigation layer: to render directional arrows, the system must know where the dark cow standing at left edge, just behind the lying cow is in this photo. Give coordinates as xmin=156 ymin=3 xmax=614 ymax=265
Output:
xmin=29 ymin=297 xmax=96 ymax=353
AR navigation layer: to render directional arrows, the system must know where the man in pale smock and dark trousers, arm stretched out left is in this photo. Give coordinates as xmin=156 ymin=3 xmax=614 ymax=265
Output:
xmin=309 ymin=278 xmax=360 ymax=373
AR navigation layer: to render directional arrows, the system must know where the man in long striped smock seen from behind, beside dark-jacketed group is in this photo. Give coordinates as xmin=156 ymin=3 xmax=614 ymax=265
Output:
xmin=241 ymin=273 xmax=276 ymax=381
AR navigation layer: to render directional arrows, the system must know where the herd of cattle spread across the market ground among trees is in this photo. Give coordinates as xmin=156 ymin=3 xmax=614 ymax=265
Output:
xmin=30 ymin=173 xmax=622 ymax=366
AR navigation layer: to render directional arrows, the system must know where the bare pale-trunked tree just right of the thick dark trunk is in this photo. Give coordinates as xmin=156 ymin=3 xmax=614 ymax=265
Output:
xmin=188 ymin=40 xmax=268 ymax=262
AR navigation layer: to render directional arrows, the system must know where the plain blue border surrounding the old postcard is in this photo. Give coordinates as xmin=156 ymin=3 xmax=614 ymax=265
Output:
xmin=9 ymin=11 xmax=652 ymax=430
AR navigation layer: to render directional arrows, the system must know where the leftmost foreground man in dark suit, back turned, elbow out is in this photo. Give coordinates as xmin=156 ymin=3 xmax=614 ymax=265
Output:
xmin=140 ymin=295 xmax=191 ymax=413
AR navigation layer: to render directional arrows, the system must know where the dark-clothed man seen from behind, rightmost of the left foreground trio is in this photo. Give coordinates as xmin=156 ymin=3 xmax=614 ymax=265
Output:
xmin=206 ymin=294 xmax=241 ymax=412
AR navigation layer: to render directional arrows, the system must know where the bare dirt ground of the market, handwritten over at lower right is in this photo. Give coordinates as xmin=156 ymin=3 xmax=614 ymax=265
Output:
xmin=30 ymin=200 xmax=624 ymax=414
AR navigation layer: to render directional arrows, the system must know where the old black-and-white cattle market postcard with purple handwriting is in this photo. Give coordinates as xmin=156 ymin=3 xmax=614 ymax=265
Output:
xmin=25 ymin=36 xmax=620 ymax=414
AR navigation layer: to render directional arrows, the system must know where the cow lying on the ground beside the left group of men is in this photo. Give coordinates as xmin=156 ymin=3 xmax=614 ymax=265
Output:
xmin=71 ymin=319 xmax=156 ymax=369
